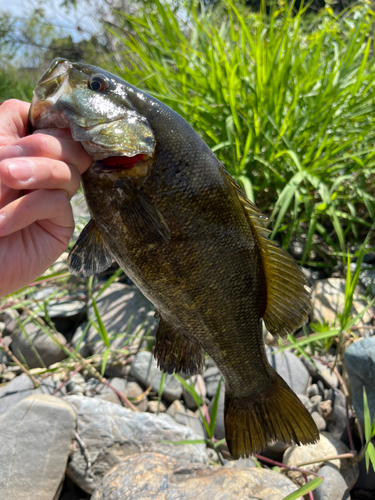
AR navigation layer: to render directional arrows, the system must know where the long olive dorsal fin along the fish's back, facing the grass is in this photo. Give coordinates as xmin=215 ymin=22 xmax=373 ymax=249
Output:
xmin=228 ymin=170 xmax=311 ymax=337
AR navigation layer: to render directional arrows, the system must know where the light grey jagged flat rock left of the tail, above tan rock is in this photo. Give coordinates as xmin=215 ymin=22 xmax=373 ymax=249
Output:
xmin=65 ymin=396 xmax=208 ymax=493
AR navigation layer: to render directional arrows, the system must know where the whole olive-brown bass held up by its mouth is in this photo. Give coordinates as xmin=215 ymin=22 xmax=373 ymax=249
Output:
xmin=29 ymin=59 xmax=319 ymax=459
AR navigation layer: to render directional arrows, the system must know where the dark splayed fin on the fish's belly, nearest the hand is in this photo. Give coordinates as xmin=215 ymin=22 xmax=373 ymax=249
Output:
xmin=68 ymin=220 xmax=112 ymax=278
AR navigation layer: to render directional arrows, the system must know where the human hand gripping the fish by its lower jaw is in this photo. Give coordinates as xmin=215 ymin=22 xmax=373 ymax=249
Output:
xmin=0 ymin=99 xmax=92 ymax=297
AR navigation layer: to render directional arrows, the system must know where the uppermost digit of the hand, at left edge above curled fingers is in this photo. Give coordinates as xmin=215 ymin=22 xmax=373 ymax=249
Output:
xmin=0 ymin=99 xmax=30 ymax=149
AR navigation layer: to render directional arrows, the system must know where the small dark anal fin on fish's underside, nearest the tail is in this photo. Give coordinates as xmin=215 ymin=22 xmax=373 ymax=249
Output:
xmin=154 ymin=318 xmax=204 ymax=375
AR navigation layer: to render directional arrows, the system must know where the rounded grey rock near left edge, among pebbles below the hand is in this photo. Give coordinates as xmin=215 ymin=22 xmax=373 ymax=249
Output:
xmin=11 ymin=323 xmax=67 ymax=368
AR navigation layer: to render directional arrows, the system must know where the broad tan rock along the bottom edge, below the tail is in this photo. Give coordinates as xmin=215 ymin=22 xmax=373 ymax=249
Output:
xmin=91 ymin=453 xmax=304 ymax=500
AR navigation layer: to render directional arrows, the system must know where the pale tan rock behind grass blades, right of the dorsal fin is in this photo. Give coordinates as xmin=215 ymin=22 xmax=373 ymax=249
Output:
xmin=310 ymin=278 xmax=372 ymax=325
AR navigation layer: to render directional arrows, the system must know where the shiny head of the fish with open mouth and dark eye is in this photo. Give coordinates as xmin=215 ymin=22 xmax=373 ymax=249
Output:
xmin=29 ymin=58 xmax=156 ymax=165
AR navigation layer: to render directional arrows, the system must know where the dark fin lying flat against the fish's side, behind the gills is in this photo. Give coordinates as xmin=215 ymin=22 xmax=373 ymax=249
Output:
xmin=116 ymin=180 xmax=170 ymax=243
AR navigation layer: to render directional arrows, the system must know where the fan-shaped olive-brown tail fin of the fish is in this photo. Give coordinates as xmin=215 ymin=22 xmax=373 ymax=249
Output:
xmin=224 ymin=372 xmax=319 ymax=458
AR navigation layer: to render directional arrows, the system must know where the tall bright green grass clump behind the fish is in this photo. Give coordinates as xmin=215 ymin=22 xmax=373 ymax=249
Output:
xmin=108 ymin=0 xmax=375 ymax=268
